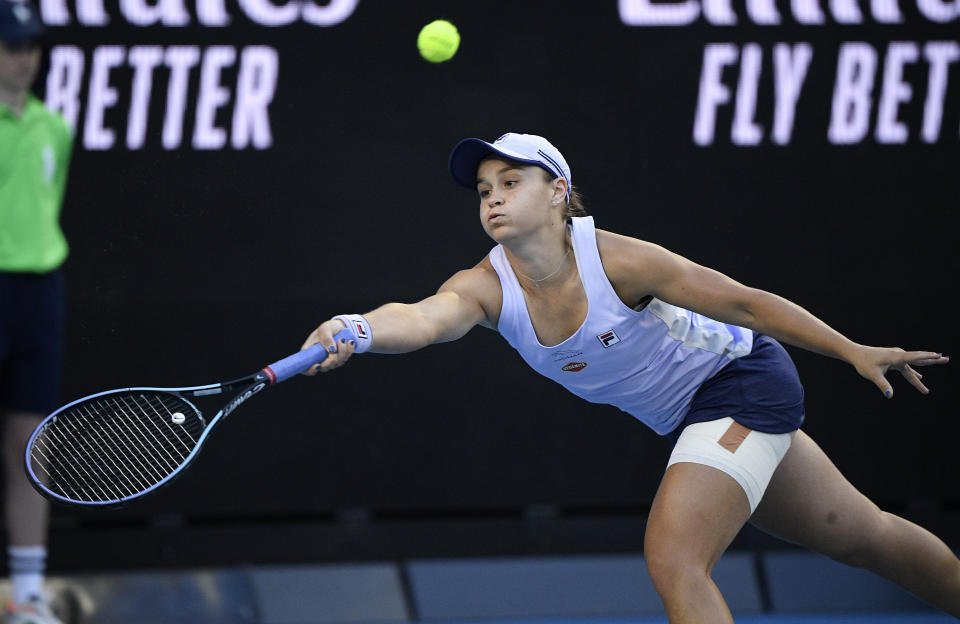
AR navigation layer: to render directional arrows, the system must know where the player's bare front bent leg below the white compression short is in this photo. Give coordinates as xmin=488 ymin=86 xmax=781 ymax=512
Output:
xmin=644 ymin=462 xmax=750 ymax=624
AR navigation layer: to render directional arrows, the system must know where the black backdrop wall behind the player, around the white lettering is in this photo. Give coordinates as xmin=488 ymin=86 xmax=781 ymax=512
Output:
xmin=31 ymin=0 xmax=960 ymax=556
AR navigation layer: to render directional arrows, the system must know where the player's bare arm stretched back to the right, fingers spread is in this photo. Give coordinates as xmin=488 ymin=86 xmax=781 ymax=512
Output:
xmin=598 ymin=232 xmax=949 ymax=398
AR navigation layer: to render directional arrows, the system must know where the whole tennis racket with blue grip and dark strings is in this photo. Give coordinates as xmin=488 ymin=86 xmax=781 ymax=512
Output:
xmin=26 ymin=330 xmax=353 ymax=507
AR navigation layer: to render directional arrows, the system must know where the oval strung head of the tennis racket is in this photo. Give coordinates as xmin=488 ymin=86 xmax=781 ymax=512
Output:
xmin=30 ymin=392 xmax=204 ymax=502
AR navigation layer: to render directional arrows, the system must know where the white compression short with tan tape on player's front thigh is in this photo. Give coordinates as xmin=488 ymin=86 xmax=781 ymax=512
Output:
xmin=667 ymin=417 xmax=793 ymax=514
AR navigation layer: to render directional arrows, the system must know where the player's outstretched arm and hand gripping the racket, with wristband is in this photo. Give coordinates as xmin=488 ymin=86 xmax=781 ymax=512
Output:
xmin=301 ymin=263 xmax=500 ymax=375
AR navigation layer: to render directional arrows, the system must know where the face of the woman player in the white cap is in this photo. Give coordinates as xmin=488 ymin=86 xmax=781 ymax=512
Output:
xmin=477 ymin=158 xmax=562 ymax=243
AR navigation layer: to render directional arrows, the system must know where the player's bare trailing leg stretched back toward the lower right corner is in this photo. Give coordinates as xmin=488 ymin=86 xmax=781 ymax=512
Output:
xmin=751 ymin=431 xmax=960 ymax=617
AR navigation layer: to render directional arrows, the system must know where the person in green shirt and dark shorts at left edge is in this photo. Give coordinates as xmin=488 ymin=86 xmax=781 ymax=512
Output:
xmin=0 ymin=0 xmax=73 ymax=624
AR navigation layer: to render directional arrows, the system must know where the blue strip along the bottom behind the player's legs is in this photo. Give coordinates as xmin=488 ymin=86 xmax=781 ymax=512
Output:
xmin=16 ymin=551 xmax=954 ymax=624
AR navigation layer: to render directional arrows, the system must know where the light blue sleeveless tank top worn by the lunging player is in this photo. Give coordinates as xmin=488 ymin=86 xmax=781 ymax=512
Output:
xmin=490 ymin=217 xmax=753 ymax=435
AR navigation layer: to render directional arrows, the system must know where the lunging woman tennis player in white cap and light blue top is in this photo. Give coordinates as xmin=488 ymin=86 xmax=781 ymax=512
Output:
xmin=303 ymin=133 xmax=960 ymax=623
